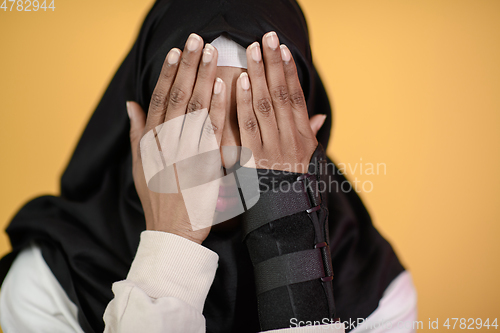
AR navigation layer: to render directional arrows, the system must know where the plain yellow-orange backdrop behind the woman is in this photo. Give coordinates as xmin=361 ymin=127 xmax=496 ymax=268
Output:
xmin=0 ymin=0 xmax=500 ymax=327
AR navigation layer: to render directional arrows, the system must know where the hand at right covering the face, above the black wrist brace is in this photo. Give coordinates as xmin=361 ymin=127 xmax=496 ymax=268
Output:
xmin=236 ymin=32 xmax=324 ymax=173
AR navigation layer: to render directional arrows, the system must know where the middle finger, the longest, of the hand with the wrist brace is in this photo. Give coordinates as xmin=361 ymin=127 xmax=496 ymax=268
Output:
xmin=262 ymin=31 xmax=297 ymax=142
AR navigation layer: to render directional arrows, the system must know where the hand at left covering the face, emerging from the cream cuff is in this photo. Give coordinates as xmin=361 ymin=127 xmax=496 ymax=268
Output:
xmin=127 ymin=34 xmax=226 ymax=244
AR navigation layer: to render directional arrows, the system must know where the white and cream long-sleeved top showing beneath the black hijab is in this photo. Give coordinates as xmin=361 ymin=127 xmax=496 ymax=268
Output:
xmin=0 ymin=231 xmax=416 ymax=333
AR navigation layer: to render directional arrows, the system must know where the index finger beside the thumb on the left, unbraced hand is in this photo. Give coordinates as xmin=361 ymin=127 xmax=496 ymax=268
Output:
xmin=146 ymin=48 xmax=181 ymax=132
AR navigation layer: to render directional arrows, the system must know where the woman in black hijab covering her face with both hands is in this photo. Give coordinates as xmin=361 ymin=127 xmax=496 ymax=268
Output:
xmin=0 ymin=1 xmax=415 ymax=332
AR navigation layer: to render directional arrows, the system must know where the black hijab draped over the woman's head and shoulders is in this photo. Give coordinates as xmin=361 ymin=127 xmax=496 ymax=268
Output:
xmin=0 ymin=0 xmax=404 ymax=332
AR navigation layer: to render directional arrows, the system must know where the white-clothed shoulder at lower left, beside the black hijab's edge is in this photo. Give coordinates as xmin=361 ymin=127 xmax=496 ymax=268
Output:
xmin=0 ymin=243 xmax=83 ymax=333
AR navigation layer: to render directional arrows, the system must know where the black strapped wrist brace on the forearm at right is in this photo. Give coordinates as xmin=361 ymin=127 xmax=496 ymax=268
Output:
xmin=243 ymin=144 xmax=335 ymax=330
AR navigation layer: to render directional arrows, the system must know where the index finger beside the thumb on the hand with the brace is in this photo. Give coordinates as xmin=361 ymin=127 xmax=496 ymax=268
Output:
xmin=280 ymin=45 xmax=314 ymax=138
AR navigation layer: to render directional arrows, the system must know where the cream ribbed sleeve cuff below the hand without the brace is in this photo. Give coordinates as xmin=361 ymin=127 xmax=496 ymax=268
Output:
xmin=127 ymin=230 xmax=219 ymax=312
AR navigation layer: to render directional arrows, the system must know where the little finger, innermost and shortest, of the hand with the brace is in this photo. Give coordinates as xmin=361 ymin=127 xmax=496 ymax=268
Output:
xmin=236 ymin=72 xmax=262 ymax=154
